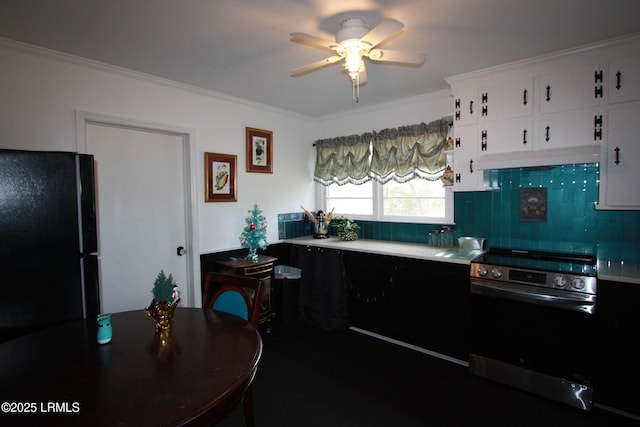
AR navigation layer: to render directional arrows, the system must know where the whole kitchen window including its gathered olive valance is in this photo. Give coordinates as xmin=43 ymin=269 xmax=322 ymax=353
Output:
xmin=314 ymin=119 xmax=453 ymax=224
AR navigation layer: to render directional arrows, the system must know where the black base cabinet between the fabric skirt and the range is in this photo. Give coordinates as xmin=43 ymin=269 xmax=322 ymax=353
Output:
xmin=343 ymin=252 xmax=469 ymax=361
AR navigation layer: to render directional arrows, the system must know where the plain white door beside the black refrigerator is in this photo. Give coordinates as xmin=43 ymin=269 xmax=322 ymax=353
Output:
xmin=86 ymin=123 xmax=189 ymax=313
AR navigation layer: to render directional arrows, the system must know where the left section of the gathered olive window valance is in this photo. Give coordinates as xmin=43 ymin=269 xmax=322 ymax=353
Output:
xmin=313 ymin=132 xmax=373 ymax=185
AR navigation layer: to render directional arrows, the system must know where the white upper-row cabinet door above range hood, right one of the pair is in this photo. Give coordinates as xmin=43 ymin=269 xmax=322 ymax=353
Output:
xmin=539 ymin=65 xmax=604 ymax=113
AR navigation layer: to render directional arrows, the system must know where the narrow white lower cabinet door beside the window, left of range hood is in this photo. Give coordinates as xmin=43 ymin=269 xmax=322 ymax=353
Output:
xmin=453 ymin=126 xmax=483 ymax=191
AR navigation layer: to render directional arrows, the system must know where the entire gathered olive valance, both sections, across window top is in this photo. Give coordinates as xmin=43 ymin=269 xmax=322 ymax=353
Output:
xmin=314 ymin=119 xmax=449 ymax=185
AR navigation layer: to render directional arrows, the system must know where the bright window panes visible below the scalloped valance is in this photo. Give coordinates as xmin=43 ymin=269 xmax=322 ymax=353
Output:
xmin=318 ymin=179 xmax=453 ymax=224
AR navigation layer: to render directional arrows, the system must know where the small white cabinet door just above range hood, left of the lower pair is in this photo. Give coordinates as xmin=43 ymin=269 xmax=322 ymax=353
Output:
xmin=480 ymin=118 xmax=534 ymax=155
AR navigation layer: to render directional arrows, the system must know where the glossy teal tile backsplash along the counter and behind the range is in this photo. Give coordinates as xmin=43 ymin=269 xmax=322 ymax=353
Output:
xmin=278 ymin=163 xmax=640 ymax=262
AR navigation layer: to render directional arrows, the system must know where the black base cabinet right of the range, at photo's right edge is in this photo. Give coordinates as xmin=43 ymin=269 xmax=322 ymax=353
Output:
xmin=593 ymin=280 xmax=640 ymax=418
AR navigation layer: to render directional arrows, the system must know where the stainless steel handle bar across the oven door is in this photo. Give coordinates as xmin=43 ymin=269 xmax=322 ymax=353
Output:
xmin=471 ymin=282 xmax=595 ymax=313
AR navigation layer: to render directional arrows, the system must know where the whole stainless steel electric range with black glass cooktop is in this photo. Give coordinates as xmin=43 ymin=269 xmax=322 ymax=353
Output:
xmin=469 ymin=248 xmax=597 ymax=410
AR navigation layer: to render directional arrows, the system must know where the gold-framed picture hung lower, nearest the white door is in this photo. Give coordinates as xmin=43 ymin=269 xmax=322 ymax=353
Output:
xmin=204 ymin=153 xmax=238 ymax=202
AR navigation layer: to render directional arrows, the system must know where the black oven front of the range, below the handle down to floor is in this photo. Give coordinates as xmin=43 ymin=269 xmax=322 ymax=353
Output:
xmin=469 ymin=279 xmax=595 ymax=410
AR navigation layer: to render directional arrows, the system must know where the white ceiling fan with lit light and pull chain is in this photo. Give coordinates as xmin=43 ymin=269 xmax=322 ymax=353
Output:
xmin=289 ymin=17 xmax=427 ymax=102
